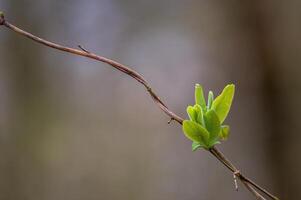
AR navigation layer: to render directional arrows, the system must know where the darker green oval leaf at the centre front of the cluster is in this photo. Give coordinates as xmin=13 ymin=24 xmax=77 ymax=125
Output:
xmin=204 ymin=110 xmax=221 ymax=141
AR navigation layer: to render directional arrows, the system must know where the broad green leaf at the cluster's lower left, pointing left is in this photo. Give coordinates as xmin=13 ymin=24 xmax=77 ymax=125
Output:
xmin=182 ymin=120 xmax=209 ymax=144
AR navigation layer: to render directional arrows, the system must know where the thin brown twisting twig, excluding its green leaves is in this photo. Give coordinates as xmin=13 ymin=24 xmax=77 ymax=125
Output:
xmin=0 ymin=12 xmax=278 ymax=200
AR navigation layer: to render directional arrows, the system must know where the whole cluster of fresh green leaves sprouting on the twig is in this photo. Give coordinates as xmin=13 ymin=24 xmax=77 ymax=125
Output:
xmin=183 ymin=84 xmax=235 ymax=151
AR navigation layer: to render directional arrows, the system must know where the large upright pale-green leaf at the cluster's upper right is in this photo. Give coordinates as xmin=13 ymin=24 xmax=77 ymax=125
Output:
xmin=212 ymin=84 xmax=235 ymax=124
